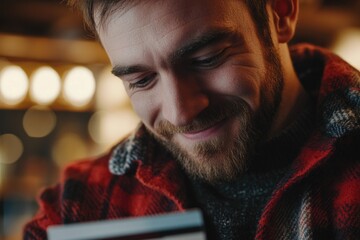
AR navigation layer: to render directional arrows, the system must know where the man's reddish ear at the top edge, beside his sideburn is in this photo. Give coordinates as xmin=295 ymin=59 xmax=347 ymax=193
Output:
xmin=271 ymin=0 xmax=299 ymax=43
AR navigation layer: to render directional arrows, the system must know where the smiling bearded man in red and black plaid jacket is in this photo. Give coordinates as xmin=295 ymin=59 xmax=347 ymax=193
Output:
xmin=25 ymin=0 xmax=360 ymax=239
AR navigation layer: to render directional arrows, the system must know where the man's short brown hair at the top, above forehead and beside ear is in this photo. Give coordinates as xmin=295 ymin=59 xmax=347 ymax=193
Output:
xmin=67 ymin=0 xmax=272 ymax=47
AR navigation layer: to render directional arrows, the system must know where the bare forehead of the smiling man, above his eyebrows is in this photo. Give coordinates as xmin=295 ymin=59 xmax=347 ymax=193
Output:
xmin=95 ymin=0 xmax=249 ymax=62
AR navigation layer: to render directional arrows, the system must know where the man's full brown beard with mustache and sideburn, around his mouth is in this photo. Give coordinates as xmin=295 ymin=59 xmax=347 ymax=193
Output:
xmin=149 ymin=48 xmax=283 ymax=183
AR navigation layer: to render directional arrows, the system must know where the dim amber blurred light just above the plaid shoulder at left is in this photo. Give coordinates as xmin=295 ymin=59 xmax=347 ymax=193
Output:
xmin=51 ymin=133 xmax=89 ymax=167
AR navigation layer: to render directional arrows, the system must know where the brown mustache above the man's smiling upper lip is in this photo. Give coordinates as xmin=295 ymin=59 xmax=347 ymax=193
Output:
xmin=155 ymin=98 xmax=249 ymax=139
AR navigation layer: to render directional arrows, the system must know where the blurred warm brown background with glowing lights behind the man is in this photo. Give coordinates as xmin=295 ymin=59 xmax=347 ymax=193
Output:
xmin=0 ymin=0 xmax=360 ymax=240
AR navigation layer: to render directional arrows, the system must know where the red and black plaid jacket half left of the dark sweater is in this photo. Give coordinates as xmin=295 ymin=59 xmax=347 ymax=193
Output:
xmin=24 ymin=127 xmax=187 ymax=240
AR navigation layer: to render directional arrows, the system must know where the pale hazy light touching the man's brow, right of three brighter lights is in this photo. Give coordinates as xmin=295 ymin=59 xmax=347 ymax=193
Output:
xmin=96 ymin=67 xmax=129 ymax=109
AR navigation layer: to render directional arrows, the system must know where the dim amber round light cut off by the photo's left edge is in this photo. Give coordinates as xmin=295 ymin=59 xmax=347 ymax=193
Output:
xmin=0 ymin=134 xmax=24 ymax=164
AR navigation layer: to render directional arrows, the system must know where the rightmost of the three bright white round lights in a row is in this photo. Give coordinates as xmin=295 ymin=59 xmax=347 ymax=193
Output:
xmin=64 ymin=67 xmax=95 ymax=107
